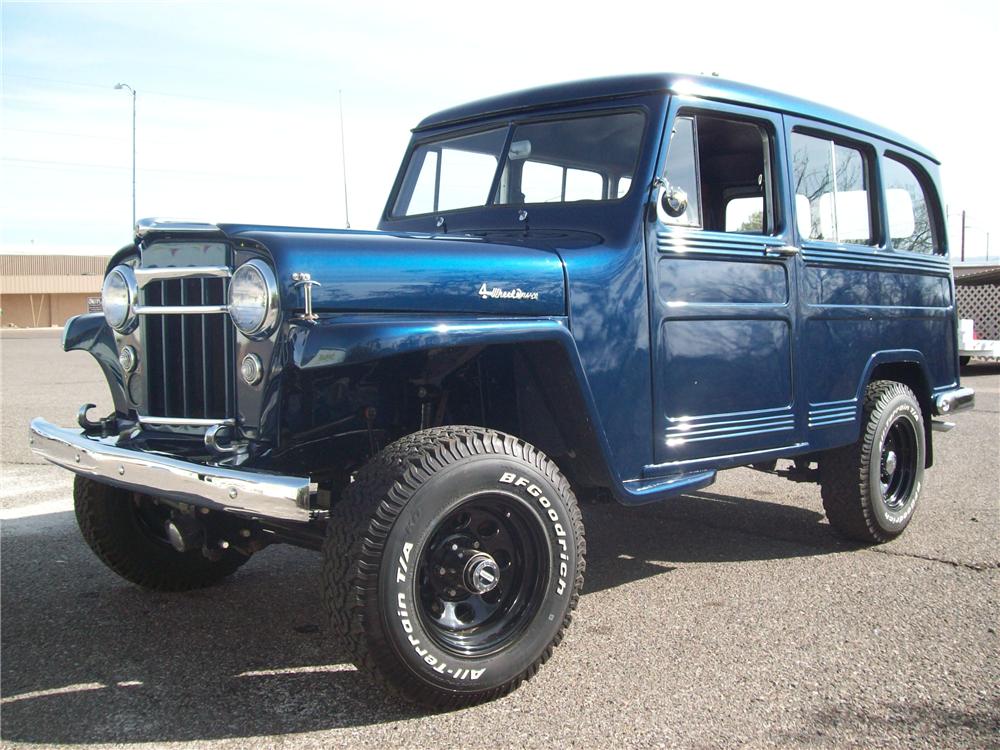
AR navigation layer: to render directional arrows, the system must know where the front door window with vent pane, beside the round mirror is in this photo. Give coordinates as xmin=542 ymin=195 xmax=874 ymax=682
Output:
xmin=665 ymin=114 xmax=775 ymax=234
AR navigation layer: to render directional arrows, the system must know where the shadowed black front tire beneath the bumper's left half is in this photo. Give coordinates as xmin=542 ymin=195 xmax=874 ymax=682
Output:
xmin=73 ymin=475 xmax=249 ymax=591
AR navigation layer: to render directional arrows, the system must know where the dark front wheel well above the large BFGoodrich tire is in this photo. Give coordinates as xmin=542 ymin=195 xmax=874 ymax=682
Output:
xmin=278 ymin=341 xmax=611 ymax=502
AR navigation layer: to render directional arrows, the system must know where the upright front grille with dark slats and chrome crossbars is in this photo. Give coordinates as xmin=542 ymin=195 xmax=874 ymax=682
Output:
xmin=137 ymin=268 xmax=236 ymax=424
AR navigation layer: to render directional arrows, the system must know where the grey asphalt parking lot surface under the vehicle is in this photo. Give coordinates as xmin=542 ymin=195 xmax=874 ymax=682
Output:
xmin=0 ymin=331 xmax=1000 ymax=748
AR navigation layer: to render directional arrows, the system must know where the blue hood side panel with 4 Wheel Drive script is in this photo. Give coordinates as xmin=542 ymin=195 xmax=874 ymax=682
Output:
xmin=220 ymin=225 xmax=566 ymax=316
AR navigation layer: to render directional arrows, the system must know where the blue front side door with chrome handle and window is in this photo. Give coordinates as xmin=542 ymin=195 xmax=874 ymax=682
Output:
xmin=646 ymin=98 xmax=803 ymax=470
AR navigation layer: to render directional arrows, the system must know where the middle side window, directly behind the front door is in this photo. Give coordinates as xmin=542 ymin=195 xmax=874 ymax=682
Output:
xmin=792 ymin=133 xmax=872 ymax=245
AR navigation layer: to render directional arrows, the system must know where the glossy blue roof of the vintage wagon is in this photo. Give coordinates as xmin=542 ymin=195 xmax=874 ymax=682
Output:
xmin=414 ymin=73 xmax=938 ymax=162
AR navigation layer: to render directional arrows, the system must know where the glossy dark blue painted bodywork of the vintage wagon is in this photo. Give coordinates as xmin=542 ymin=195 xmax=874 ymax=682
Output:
xmin=74 ymin=75 xmax=958 ymax=503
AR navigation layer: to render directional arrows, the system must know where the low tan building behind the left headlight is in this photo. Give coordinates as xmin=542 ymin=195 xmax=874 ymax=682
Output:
xmin=0 ymin=255 xmax=109 ymax=328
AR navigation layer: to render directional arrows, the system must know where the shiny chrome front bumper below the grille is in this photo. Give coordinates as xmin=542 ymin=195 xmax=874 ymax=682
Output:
xmin=28 ymin=418 xmax=313 ymax=522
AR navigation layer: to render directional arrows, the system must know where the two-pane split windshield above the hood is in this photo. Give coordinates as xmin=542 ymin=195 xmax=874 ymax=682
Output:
xmin=392 ymin=112 xmax=645 ymax=216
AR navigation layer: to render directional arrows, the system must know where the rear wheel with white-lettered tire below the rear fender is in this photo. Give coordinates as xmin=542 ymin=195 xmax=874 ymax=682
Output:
xmin=820 ymin=380 xmax=926 ymax=543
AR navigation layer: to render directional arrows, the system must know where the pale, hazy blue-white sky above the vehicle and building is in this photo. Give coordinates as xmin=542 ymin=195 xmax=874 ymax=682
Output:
xmin=0 ymin=0 xmax=1000 ymax=261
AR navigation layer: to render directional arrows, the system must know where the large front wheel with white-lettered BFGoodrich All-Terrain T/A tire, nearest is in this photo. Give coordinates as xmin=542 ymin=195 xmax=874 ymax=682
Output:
xmin=323 ymin=427 xmax=585 ymax=709
